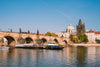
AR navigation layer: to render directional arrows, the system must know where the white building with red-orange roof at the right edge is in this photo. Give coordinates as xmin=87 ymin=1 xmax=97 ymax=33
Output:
xmin=85 ymin=30 xmax=100 ymax=43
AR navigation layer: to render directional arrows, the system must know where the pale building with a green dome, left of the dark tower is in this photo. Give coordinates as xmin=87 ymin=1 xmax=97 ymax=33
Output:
xmin=57 ymin=24 xmax=75 ymax=38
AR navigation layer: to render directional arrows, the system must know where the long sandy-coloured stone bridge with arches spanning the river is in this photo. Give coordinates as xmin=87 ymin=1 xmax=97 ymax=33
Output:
xmin=0 ymin=31 xmax=70 ymax=46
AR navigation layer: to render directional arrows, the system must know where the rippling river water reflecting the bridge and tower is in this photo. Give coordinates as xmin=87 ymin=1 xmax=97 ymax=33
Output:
xmin=0 ymin=47 xmax=100 ymax=67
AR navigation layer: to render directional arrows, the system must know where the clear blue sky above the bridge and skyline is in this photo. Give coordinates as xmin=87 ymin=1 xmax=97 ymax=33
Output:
xmin=0 ymin=0 xmax=100 ymax=33
